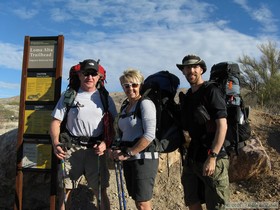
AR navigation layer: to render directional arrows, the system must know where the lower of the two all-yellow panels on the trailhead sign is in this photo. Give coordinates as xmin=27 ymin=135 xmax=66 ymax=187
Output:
xmin=24 ymin=106 xmax=52 ymax=134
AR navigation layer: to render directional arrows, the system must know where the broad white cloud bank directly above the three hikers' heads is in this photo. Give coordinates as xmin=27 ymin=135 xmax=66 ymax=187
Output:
xmin=61 ymin=23 xmax=260 ymax=90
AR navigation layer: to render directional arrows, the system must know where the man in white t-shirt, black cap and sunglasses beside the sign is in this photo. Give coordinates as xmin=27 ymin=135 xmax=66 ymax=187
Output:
xmin=50 ymin=59 xmax=117 ymax=210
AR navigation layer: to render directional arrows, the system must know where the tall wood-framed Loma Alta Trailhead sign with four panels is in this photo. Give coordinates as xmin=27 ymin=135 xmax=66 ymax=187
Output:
xmin=14 ymin=35 xmax=64 ymax=210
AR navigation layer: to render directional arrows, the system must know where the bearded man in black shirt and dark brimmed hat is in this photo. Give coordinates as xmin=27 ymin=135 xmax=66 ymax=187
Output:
xmin=177 ymin=55 xmax=229 ymax=210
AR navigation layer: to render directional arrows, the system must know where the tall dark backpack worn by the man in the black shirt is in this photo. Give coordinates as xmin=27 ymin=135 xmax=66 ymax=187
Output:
xmin=210 ymin=62 xmax=251 ymax=154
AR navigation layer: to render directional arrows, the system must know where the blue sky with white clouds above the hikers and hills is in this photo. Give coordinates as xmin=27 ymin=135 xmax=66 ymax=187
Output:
xmin=0 ymin=0 xmax=280 ymax=98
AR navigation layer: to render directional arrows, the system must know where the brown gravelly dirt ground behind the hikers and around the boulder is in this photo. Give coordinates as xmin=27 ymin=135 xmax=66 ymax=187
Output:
xmin=73 ymin=110 xmax=280 ymax=210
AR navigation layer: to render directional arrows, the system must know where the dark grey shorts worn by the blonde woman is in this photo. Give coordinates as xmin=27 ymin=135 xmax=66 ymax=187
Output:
xmin=123 ymin=159 xmax=159 ymax=202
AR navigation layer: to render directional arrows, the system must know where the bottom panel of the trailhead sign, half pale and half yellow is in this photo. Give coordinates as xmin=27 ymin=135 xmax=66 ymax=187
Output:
xmin=22 ymin=143 xmax=52 ymax=169
